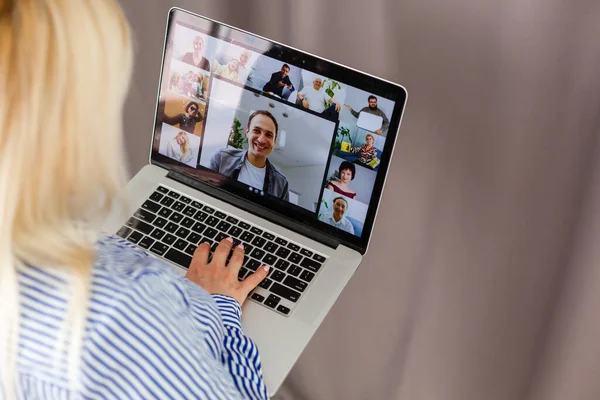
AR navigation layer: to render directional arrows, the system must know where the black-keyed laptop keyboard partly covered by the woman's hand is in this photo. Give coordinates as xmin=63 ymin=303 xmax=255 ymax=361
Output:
xmin=117 ymin=186 xmax=326 ymax=316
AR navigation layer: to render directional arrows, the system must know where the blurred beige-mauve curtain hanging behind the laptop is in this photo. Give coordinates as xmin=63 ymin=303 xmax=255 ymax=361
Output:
xmin=121 ymin=0 xmax=600 ymax=400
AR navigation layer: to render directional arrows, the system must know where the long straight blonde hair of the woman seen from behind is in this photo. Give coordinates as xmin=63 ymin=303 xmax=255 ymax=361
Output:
xmin=0 ymin=0 xmax=131 ymax=398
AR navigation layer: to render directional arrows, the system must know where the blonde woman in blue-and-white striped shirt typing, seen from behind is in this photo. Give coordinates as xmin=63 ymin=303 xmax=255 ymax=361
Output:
xmin=0 ymin=0 xmax=268 ymax=399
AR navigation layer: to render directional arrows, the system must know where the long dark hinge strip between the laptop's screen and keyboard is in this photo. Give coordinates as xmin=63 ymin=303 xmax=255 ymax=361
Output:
xmin=167 ymin=170 xmax=340 ymax=249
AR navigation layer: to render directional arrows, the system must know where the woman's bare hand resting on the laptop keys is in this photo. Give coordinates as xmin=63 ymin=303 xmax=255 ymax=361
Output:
xmin=185 ymin=238 xmax=269 ymax=306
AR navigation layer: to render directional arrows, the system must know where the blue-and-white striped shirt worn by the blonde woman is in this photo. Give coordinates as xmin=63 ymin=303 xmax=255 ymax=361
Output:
xmin=6 ymin=237 xmax=268 ymax=399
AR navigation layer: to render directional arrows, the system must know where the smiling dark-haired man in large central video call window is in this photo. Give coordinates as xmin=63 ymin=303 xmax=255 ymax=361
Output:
xmin=209 ymin=110 xmax=289 ymax=201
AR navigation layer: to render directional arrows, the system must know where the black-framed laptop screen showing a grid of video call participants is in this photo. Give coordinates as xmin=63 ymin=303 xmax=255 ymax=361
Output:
xmin=151 ymin=9 xmax=406 ymax=253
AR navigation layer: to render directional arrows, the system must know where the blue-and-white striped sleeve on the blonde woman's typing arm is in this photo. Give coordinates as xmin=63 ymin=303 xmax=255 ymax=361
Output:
xmin=83 ymin=257 xmax=268 ymax=399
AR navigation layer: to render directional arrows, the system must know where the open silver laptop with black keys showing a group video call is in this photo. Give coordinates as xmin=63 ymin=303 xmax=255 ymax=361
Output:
xmin=104 ymin=8 xmax=406 ymax=395
